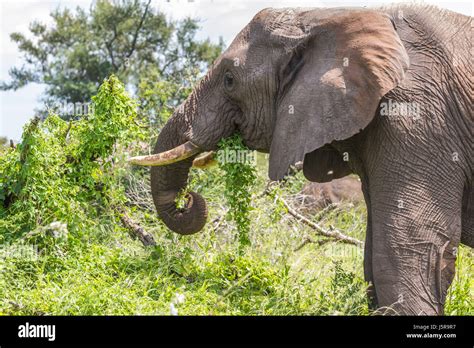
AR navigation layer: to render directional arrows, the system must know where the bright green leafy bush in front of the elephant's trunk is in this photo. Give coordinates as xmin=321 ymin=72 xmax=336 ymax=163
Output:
xmin=0 ymin=76 xmax=142 ymax=239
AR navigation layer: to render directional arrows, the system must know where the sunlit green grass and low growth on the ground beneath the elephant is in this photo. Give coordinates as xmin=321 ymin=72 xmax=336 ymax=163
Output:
xmin=0 ymin=157 xmax=474 ymax=315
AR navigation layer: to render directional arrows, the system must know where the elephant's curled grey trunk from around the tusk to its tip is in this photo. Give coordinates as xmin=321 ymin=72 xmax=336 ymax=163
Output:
xmin=151 ymin=117 xmax=207 ymax=235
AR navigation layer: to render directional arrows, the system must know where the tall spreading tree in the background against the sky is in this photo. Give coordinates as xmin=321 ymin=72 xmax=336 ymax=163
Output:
xmin=0 ymin=0 xmax=223 ymax=119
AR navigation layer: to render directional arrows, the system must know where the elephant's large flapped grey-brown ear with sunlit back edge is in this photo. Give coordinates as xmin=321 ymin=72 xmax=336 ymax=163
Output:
xmin=269 ymin=10 xmax=409 ymax=180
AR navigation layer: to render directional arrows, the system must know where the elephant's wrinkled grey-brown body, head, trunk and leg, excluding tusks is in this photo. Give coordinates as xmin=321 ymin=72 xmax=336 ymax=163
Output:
xmin=151 ymin=6 xmax=474 ymax=315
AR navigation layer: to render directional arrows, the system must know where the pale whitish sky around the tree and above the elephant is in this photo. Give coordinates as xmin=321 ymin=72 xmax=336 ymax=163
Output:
xmin=0 ymin=0 xmax=473 ymax=141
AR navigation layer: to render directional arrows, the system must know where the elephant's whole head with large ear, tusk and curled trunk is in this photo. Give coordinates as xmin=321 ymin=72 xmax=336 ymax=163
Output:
xmin=132 ymin=9 xmax=408 ymax=234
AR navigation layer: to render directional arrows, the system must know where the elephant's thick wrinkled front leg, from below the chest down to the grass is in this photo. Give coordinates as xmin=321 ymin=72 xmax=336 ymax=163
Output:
xmin=370 ymin=173 xmax=463 ymax=315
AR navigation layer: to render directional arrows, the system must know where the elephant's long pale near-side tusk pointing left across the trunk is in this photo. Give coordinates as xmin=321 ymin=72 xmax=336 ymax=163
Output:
xmin=128 ymin=141 xmax=202 ymax=166
